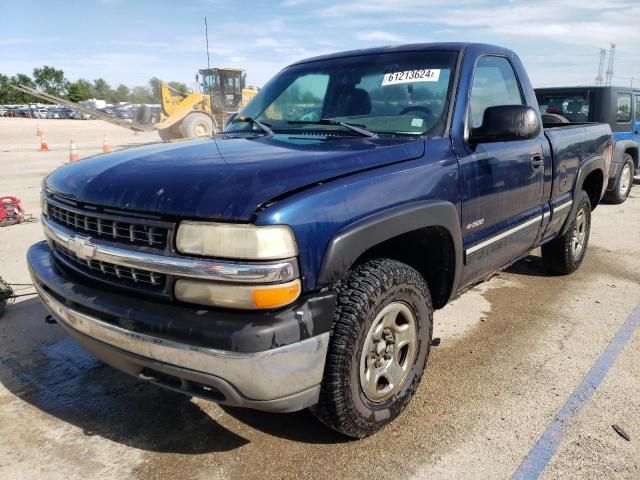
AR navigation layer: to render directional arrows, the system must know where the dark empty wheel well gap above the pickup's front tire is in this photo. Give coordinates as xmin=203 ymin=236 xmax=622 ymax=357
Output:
xmin=354 ymin=227 xmax=456 ymax=308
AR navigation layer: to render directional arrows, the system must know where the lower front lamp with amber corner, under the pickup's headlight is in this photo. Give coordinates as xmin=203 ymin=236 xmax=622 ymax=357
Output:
xmin=175 ymin=279 xmax=300 ymax=310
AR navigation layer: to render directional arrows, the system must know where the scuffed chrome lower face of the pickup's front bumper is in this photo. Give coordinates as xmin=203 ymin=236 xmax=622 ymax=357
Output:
xmin=36 ymin=286 xmax=329 ymax=411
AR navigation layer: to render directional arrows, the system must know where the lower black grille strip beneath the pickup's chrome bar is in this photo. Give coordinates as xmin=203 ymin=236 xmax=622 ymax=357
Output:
xmin=55 ymin=244 xmax=167 ymax=291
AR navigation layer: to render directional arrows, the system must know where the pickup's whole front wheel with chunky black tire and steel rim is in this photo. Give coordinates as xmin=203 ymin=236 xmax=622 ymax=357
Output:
xmin=311 ymin=259 xmax=433 ymax=438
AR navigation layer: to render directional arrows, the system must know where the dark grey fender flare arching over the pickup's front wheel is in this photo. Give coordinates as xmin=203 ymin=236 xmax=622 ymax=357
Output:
xmin=318 ymin=200 xmax=463 ymax=297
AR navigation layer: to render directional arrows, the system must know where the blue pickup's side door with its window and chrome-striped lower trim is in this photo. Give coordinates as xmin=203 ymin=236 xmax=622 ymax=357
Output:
xmin=458 ymin=55 xmax=544 ymax=282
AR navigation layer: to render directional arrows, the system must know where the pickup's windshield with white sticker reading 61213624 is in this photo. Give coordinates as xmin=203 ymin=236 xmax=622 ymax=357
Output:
xmin=225 ymin=51 xmax=457 ymax=136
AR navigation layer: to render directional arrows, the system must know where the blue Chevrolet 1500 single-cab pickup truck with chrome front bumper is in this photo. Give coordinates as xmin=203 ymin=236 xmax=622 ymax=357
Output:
xmin=28 ymin=43 xmax=612 ymax=437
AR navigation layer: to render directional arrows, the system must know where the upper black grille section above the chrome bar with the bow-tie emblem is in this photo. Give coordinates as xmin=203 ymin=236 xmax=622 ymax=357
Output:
xmin=47 ymin=202 xmax=168 ymax=249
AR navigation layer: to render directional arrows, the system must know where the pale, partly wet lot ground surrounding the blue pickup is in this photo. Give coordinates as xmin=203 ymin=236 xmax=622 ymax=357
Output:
xmin=0 ymin=118 xmax=640 ymax=480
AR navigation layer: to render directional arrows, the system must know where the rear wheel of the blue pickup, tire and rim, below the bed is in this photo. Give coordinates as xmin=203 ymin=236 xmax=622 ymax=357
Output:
xmin=542 ymin=190 xmax=591 ymax=275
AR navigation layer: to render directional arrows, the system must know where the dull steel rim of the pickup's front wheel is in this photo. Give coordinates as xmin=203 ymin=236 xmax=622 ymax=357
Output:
xmin=360 ymin=302 xmax=417 ymax=403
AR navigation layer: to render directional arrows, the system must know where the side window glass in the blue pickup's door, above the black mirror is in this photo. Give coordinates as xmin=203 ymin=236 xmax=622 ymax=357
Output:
xmin=469 ymin=55 xmax=524 ymax=128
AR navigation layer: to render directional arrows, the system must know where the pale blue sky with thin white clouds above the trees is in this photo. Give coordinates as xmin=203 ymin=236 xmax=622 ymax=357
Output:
xmin=0 ymin=0 xmax=640 ymax=88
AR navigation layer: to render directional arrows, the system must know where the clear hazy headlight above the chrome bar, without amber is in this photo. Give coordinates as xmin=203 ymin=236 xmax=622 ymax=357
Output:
xmin=176 ymin=221 xmax=298 ymax=260
